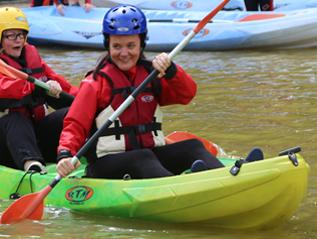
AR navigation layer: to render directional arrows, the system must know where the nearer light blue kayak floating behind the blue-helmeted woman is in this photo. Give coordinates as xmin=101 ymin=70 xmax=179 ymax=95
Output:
xmin=23 ymin=6 xmax=317 ymax=51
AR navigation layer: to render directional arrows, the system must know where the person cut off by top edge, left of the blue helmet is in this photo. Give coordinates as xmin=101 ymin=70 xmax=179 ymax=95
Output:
xmin=30 ymin=0 xmax=93 ymax=16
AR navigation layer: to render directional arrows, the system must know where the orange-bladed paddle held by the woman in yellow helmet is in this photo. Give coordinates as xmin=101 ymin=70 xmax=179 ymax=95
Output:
xmin=0 ymin=59 xmax=74 ymax=105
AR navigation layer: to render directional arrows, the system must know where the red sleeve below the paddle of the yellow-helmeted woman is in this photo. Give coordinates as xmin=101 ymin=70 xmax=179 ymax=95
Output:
xmin=0 ymin=74 xmax=34 ymax=99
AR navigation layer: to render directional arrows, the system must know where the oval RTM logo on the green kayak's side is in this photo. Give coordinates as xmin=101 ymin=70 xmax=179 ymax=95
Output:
xmin=65 ymin=186 xmax=94 ymax=204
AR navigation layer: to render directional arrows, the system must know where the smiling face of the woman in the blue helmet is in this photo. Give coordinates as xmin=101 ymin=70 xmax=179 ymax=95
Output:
xmin=109 ymin=35 xmax=141 ymax=71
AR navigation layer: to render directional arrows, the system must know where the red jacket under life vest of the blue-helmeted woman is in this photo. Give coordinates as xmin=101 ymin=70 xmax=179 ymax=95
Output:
xmin=58 ymin=58 xmax=197 ymax=155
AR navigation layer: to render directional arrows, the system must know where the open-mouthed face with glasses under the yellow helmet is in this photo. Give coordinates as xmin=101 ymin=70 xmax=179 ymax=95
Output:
xmin=1 ymin=29 xmax=26 ymax=58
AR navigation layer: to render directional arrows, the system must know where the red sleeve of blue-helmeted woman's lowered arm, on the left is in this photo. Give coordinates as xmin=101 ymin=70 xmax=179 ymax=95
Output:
xmin=58 ymin=75 xmax=111 ymax=155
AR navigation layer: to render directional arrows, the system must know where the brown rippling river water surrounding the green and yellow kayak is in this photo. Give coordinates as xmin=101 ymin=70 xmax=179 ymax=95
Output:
xmin=0 ymin=1 xmax=317 ymax=239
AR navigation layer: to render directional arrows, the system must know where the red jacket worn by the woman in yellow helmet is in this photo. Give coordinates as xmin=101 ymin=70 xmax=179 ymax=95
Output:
xmin=0 ymin=44 xmax=78 ymax=119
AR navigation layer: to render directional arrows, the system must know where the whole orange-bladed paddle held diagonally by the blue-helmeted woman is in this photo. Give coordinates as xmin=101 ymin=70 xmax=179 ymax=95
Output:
xmin=0 ymin=0 xmax=229 ymax=224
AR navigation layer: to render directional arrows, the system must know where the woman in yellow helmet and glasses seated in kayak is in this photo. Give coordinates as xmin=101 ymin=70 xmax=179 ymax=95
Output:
xmin=0 ymin=7 xmax=78 ymax=174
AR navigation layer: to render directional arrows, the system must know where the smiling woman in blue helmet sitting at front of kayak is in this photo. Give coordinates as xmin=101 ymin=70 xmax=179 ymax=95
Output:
xmin=57 ymin=5 xmax=223 ymax=178
